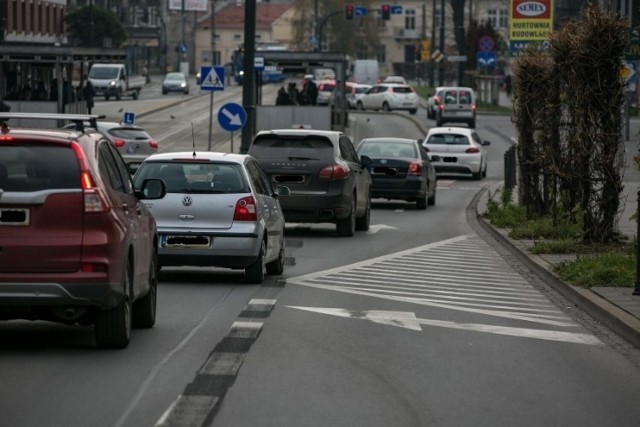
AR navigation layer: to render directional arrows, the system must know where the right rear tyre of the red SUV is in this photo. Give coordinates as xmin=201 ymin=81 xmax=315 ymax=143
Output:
xmin=94 ymin=260 xmax=132 ymax=348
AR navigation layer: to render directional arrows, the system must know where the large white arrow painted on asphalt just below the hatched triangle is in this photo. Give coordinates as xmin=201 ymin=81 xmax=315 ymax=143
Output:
xmin=287 ymin=305 xmax=602 ymax=345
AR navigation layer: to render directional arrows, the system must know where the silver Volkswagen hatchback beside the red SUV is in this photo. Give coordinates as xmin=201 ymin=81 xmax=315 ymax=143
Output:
xmin=134 ymin=152 xmax=289 ymax=283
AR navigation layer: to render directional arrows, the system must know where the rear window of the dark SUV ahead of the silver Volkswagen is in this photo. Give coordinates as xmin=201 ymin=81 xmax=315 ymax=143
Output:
xmin=249 ymin=137 xmax=333 ymax=160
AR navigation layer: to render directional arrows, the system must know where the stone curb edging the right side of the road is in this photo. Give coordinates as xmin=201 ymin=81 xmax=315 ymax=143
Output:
xmin=467 ymin=188 xmax=640 ymax=349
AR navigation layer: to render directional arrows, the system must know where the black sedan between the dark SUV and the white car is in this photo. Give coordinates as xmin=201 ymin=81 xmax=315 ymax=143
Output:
xmin=357 ymin=137 xmax=438 ymax=209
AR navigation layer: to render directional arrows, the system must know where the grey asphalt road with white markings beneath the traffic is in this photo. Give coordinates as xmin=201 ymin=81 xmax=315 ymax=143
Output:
xmin=0 ymin=91 xmax=640 ymax=427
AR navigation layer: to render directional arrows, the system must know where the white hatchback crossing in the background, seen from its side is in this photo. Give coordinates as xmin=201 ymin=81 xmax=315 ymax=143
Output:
xmin=357 ymin=83 xmax=420 ymax=114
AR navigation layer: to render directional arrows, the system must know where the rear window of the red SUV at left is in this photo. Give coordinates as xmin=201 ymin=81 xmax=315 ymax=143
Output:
xmin=0 ymin=143 xmax=80 ymax=192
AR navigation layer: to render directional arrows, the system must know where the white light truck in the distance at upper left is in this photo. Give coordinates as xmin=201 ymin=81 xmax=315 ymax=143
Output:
xmin=88 ymin=63 xmax=146 ymax=101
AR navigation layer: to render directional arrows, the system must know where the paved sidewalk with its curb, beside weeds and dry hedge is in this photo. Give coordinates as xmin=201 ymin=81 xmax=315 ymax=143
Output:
xmin=473 ymin=182 xmax=640 ymax=348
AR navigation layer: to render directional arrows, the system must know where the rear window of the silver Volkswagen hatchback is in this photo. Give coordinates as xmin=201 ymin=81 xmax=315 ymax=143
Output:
xmin=134 ymin=161 xmax=249 ymax=194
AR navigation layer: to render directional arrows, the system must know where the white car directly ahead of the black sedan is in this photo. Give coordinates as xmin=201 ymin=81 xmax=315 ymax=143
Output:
xmin=422 ymin=127 xmax=491 ymax=179
